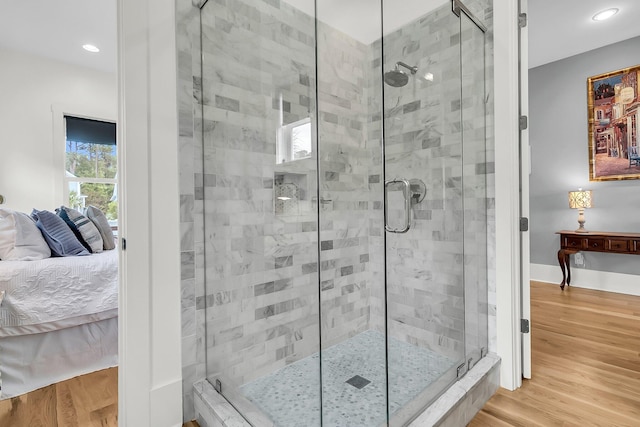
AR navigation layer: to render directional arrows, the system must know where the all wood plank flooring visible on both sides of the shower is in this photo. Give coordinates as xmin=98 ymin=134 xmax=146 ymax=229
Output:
xmin=0 ymin=282 xmax=640 ymax=427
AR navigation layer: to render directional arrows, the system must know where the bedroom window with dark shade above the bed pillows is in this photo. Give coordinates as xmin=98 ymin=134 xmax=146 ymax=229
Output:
xmin=64 ymin=116 xmax=118 ymax=225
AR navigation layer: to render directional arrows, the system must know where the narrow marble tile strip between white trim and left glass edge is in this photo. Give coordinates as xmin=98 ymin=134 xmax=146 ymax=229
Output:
xmin=176 ymin=0 xmax=205 ymax=421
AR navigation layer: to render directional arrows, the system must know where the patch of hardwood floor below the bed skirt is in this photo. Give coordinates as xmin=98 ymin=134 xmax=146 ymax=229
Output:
xmin=0 ymin=368 xmax=118 ymax=427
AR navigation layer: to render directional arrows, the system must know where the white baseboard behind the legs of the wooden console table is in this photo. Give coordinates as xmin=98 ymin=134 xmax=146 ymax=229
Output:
xmin=531 ymin=264 xmax=640 ymax=296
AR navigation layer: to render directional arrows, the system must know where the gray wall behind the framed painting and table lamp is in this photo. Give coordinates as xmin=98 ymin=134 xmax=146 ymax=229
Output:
xmin=529 ymin=37 xmax=640 ymax=274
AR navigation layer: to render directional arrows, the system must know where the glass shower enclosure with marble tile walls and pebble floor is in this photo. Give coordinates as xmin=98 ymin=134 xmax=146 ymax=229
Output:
xmin=200 ymin=0 xmax=488 ymax=427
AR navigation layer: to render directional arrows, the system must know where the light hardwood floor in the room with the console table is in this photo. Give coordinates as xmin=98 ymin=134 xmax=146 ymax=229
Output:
xmin=469 ymin=281 xmax=640 ymax=427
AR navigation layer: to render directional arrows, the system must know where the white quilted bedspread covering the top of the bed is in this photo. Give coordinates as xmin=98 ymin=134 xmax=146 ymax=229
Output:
xmin=0 ymin=250 xmax=118 ymax=338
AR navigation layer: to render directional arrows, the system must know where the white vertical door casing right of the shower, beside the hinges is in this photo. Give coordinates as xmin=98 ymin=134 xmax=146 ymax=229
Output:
xmin=493 ymin=1 xmax=522 ymax=390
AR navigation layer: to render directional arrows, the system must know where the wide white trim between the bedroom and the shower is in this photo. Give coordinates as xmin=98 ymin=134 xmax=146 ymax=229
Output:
xmin=118 ymin=0 xmax=182 ymax=426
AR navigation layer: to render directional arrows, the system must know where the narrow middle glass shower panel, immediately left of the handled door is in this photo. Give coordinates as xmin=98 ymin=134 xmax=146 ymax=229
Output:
xmin=316 ymin=0 xmax=388 ymax=427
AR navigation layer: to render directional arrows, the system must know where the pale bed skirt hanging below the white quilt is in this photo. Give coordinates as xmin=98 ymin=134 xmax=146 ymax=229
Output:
xmin=0 ymin=317 xmax=118 ymax=399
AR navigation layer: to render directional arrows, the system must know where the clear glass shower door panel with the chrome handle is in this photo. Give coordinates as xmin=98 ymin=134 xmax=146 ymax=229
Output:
xmin=378 ymin=4 xmax=466 ymax=426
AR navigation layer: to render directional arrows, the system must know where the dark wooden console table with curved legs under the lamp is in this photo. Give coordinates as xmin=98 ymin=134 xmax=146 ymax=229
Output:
xmin=556 ymin=230 xmax=640 ymax=290
